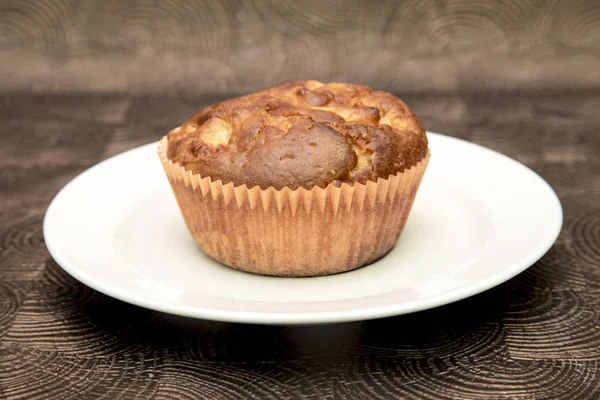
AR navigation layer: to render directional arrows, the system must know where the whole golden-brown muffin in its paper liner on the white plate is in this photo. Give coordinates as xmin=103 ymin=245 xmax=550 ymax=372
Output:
xmin=158 ymin=81 xmax=429 ymax=276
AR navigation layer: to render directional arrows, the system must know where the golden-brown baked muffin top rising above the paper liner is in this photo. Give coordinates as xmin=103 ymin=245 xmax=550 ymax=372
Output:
xmin=167 ymin=81 xmax=427 ymax=189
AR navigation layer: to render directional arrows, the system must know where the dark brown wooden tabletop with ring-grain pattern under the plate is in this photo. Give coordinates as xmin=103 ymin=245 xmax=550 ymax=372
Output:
xmin=0 ymin=91 xmax=600 ymax=400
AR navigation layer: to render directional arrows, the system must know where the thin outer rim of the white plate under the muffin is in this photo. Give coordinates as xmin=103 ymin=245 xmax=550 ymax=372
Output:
xmin=42 ymin=131 xmax=564 ymax=325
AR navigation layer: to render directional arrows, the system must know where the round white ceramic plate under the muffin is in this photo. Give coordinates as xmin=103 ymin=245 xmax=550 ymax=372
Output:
xmin=44 ymin=133 xmax=562 ymax=324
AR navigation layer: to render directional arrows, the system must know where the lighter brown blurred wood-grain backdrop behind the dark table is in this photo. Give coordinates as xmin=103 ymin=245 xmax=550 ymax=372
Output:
xmin=0 ymin=0 xmax=600 ymax=93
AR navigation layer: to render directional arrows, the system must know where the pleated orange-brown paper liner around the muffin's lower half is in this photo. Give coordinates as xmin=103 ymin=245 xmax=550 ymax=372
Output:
xmin=158 ymin=136 xmax=430 ymax=276
